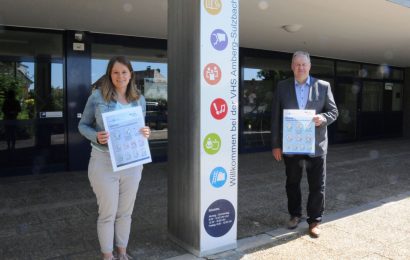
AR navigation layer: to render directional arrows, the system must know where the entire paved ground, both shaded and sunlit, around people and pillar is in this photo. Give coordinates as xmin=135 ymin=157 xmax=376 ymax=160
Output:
xmin=0 ymin=138 xmax=410 ymax=259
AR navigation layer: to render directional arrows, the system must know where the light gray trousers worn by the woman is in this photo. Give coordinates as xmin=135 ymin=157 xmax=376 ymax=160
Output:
xmin=88 ymin=148 xmax=143 ymax=253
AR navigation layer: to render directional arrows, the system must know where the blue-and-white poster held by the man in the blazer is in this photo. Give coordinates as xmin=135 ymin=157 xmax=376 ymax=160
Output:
xmin=282 ymin=109 xmax=315 ymax=154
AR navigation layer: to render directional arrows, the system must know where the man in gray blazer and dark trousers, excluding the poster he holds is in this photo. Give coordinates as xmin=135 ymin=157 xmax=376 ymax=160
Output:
xmin=272 ymin=51 xmax=338 ymax=238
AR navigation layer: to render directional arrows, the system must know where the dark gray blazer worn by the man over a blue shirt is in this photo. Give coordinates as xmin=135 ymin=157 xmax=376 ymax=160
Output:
xmin=271 ymin=77 xmax=339 ymax=157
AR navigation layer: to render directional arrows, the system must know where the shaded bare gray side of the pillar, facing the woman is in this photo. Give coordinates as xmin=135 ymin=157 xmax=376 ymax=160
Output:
xmin=168 ymin=0 xmax=201 ymax=254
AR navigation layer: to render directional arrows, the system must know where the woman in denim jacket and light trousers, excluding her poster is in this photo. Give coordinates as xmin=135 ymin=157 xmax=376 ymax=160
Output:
xmin=78 ymin=56 xmax=150 ymax=260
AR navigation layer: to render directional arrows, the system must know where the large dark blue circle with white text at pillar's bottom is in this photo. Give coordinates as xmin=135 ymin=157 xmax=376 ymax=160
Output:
xmin=204 ymin=199 xmax=235 ymax=237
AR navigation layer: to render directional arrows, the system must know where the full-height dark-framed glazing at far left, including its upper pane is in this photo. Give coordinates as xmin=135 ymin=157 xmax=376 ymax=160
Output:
xmin=0 ymin=29 xmax=66 ymax=176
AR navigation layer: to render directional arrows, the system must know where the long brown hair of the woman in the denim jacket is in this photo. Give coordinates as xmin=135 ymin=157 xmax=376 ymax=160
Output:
xmin=99 ymin=56 xmax=140 ymax=102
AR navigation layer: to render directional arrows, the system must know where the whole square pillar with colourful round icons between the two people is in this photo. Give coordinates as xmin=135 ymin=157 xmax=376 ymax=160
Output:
xmin=168 ymin=0 xmax=239 ymax=256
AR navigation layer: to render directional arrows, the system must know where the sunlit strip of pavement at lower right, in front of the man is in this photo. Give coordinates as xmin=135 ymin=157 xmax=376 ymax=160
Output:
xmin=168 ymin=192 xmax=410 ymax=260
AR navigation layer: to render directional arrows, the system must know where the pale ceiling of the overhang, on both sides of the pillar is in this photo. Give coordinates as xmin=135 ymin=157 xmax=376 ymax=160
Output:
xmin=0 ymin=0 xmax=410 ymax=67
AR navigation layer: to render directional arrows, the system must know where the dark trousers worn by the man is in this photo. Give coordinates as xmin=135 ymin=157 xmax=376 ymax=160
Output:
xmin=283 ymin=155 xmax=326 ymax=224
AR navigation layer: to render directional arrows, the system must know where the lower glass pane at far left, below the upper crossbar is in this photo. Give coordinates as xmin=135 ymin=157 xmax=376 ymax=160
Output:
xmin=0 ymin=59 xmax=66 ymax=176
